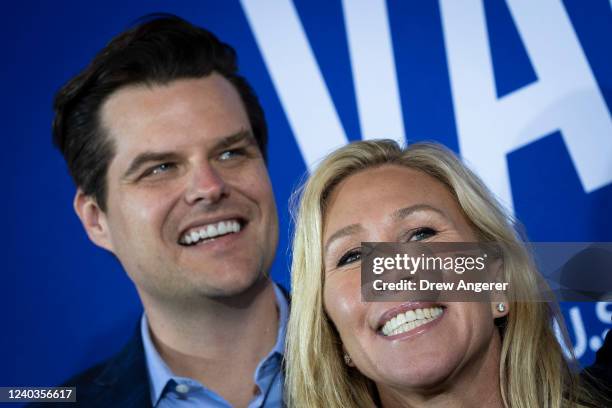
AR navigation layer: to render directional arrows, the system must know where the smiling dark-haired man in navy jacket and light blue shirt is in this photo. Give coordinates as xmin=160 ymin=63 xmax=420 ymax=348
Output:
xmin=47 ymin=16 xmax=287 ymax=407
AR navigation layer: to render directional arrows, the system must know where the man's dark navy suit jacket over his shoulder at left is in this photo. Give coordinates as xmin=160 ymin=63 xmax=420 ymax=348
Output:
xmin=29 ymin=324 xmax=151 ymax=408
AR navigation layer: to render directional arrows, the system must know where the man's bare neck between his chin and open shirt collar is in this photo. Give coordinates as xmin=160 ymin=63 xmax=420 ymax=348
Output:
xmin=143 ymin=279 xmax=279 ymax=406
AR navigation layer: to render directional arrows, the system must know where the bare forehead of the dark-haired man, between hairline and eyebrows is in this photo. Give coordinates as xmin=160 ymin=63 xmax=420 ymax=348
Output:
xmin=100 ymin=74 xmax=251 ymax=154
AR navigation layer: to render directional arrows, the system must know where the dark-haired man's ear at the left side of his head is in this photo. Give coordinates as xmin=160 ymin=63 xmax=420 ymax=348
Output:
xmin=73 ymin=188 xmax=114 ymax=252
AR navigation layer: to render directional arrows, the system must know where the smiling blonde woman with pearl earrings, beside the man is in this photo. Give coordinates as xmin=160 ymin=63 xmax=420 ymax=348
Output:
xmin=286 ymin=140 xmax=597 ymax=408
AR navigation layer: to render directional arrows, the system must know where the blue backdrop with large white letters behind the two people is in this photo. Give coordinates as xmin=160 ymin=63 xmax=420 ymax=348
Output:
xmin=0 ymin=0 xmax=612 ymax=385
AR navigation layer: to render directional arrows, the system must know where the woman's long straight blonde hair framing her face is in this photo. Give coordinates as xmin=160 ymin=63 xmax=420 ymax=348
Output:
xmin=285 ymin=140 xmax=596 ymax=408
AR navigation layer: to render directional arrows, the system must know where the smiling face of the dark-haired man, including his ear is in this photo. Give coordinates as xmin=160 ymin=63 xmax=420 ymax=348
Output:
xmin=75 ymin=73 xmax=278 ymax=301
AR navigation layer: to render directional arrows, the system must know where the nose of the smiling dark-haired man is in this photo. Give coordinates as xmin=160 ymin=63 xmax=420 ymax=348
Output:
xmin=185 ymin=163 xmax=229 ymax=205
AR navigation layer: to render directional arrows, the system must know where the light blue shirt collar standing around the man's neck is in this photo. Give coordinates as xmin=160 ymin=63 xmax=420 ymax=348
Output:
xmin=140 ymin=282 xmax=289 ymax=407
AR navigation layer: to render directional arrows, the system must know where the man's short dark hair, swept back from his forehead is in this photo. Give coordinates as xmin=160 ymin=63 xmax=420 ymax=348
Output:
xmin=53 ymin=14 xmax=268 ymax=211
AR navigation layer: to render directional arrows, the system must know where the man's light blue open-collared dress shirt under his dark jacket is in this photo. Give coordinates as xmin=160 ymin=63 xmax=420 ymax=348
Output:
xmin=140 ymin=284 xmax=289 ymax=408
